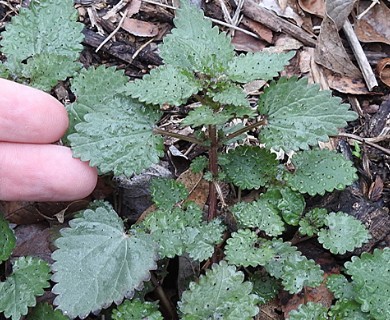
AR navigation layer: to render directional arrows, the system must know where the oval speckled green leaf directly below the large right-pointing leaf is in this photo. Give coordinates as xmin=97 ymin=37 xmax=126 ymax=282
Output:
xmin=284 ymin=149 xmax=358 ymax=196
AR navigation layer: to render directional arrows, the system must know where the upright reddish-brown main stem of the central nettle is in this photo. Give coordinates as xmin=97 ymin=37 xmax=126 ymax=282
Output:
xmin=207 ymin=125 xmax=218 ymax=221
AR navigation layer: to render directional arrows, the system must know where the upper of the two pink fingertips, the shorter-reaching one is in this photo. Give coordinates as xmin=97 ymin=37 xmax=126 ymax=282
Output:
xmin=0 ymin=79 xmax=69 ymax=143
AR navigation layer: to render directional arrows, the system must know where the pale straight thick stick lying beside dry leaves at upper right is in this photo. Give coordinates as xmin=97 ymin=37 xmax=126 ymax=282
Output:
xmin=343 ymin=20 xmax=378 ymax=91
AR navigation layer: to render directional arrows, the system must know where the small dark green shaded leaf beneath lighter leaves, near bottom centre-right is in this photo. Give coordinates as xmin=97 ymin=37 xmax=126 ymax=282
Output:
xmin=249 ymin=272 xmax=280 ymax=304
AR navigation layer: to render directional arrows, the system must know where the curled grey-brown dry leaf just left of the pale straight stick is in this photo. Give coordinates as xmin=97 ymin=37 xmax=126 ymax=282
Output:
xmin=315 ymin=17 xmax=361 ymax=78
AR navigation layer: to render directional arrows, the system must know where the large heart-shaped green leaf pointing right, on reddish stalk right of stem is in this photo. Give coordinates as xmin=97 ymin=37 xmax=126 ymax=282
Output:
xmin=259 ymin=77 xmax=356 ymax=153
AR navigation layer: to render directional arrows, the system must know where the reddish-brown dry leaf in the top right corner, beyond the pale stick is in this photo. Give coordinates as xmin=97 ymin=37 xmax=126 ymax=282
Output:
xmin=355 ymin=1 xmax=390 ymax=44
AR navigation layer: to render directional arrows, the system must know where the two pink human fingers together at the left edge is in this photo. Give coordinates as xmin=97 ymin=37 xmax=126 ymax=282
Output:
xmin=0 ymin=79 xmax=97 ymax=201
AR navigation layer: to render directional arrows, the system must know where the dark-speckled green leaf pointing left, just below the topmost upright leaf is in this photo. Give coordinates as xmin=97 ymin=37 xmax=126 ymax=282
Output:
xmin=127 ymin=65 xmax=201 ymax=106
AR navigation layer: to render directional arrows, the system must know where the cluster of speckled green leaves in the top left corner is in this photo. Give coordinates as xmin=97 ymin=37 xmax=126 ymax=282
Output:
xmin=0 ymin=0 xmax=83 ymax=91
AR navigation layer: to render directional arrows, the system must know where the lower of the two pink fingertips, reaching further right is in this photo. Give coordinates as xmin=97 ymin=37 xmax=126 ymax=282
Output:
xmin=0 ymin=142 xmax=97 ymax=201
